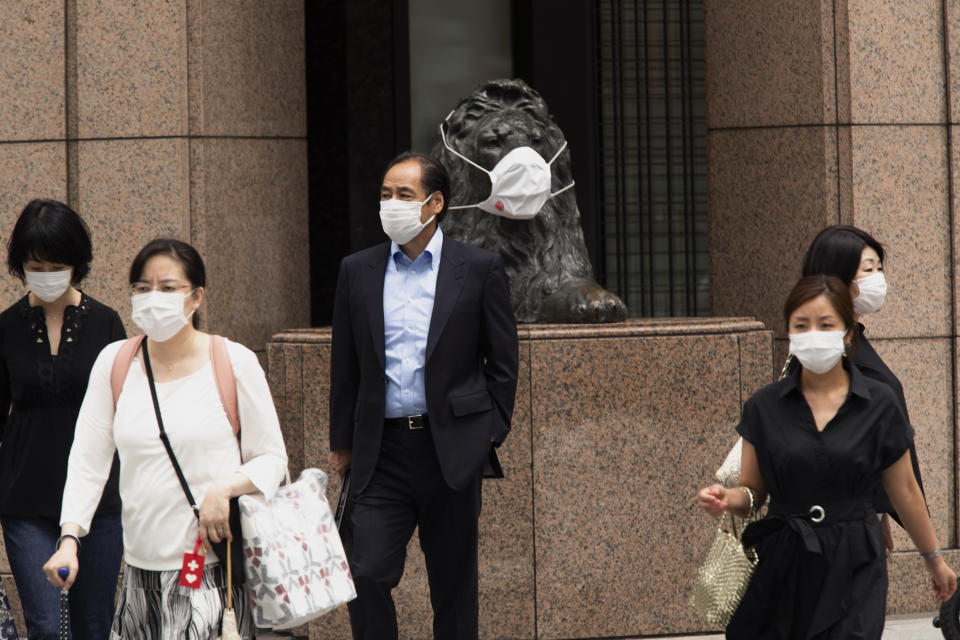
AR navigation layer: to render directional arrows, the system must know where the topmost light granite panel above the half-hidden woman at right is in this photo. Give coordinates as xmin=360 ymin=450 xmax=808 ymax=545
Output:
xmin=837 ymin=0 xmax=948 ymax=124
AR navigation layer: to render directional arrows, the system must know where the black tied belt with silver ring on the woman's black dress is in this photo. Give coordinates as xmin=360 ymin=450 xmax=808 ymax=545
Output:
xmin=742 ymin=498 xmax=877 ymax=554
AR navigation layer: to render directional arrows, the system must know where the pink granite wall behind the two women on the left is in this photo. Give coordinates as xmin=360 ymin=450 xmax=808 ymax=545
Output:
xmin=0 ymin=0 xmax=310 ymax=631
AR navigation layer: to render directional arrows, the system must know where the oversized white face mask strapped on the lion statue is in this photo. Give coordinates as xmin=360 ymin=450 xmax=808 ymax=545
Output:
xmin=440 ymin=117 xmax=574 ymax=220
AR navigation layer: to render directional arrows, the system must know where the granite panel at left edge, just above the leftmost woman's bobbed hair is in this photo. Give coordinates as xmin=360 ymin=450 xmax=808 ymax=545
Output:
xmin=0 ymin=144 xmax=66 ymax=309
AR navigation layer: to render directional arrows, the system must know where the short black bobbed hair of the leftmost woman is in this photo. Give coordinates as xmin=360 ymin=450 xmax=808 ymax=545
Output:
xmin=7 ymin=200 xmax=93 ymax=284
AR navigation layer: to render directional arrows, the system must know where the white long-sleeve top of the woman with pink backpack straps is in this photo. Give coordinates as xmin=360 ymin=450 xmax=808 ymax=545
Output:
xmin=60 ymin=340 xmax=287 ymax=571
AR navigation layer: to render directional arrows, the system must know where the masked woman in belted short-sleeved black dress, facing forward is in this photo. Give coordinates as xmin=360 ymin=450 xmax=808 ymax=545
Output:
xmin=699 ymin=276 xmax=957 ymax=640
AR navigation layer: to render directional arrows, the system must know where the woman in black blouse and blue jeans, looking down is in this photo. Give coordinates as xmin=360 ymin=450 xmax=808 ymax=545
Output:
xmin=0 ymin=200 xmax=126 ymax=640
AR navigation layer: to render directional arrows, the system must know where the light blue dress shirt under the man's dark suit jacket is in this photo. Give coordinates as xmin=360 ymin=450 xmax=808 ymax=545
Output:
xmin=383 ymin=227 xmax=443 ymax=418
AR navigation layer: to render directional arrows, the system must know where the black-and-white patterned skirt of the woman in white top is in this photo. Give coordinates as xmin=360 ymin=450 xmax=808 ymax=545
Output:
xmin=110 ymin=564 xmax=255 ymax=640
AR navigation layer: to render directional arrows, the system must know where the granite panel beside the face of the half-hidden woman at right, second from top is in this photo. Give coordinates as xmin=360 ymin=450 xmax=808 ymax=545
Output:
xmin=852 ymin=126 xmax=953 ymax=337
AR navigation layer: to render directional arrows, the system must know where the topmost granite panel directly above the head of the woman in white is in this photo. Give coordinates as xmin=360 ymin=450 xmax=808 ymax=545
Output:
xmin=75 ymin=0 xmax=187 ymax=138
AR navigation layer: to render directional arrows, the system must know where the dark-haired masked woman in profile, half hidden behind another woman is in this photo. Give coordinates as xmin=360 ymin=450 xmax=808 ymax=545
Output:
xmin=803 ymin=225 xmax=923 ymax=551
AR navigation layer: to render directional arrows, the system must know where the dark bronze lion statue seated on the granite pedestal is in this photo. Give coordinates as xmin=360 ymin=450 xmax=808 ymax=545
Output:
xmin=432 ymin=80 xmax=627 ymax=323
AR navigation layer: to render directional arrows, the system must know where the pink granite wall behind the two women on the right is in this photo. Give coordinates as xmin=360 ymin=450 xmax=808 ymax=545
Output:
xmin=704 ymin=0 xmax=960 ymax=613
